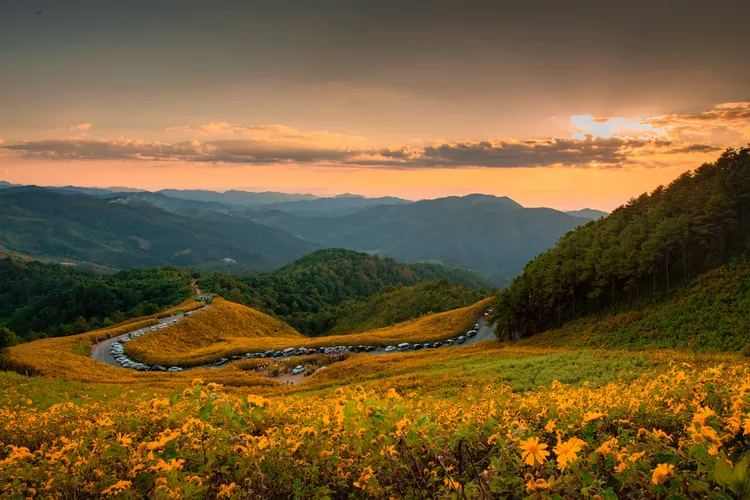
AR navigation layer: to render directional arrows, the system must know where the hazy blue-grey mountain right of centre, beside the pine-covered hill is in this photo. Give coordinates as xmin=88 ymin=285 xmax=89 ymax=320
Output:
xmin=245 ymin=194 xmax=586 ymax=284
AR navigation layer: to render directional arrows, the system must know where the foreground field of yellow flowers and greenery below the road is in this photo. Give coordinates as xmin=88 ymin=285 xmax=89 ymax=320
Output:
xmin=0 ymin=344 xmax=750 ymax=498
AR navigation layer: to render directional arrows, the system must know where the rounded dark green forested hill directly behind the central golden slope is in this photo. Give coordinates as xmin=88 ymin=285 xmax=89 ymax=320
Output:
xmin=200 ymin=249 xmax=491 ymax=334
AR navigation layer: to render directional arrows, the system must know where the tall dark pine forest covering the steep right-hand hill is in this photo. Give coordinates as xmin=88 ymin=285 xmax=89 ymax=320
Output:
xmin=496 ymin=148 xmax=750 ymax=336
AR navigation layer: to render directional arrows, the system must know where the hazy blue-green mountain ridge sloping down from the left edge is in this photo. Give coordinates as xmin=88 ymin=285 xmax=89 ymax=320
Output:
xmin=0 ymin=188 xmax=317 ymax=270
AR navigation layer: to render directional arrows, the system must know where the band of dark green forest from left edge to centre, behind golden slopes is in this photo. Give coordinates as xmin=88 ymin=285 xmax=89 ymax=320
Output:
xmin=0 ymin=249 xmax=490 ymax=340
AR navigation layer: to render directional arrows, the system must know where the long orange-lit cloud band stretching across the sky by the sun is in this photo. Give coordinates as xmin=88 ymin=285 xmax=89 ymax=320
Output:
xmin=2 ymin=102 xmax=750 ymax=169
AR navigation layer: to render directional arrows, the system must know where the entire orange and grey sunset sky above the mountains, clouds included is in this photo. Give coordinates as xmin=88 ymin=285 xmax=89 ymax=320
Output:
xmin=0 ymin=0 xmax=750 ymax=210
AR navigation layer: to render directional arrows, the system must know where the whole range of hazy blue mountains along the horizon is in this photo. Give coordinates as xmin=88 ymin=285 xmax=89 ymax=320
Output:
xmin=0 ymin=183 xmax=603 ymax=285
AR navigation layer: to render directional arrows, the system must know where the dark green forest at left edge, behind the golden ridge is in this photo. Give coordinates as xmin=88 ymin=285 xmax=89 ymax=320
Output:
xmin=0 ymin=258 xmax=192 ymax=340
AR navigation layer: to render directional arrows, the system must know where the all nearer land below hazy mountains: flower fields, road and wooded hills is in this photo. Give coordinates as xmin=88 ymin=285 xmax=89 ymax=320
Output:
xmin=0 ymin=150 xmax=750 ymax=499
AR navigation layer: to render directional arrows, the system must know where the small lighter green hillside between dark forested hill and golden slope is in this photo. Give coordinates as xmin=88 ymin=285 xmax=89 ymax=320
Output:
xmin=327 ymin=278 xmax=485 ymax=335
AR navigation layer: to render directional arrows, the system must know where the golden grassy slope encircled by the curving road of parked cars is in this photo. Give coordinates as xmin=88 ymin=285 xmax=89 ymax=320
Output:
xmin=126 ymin=299 xmax=491 ymax=366
